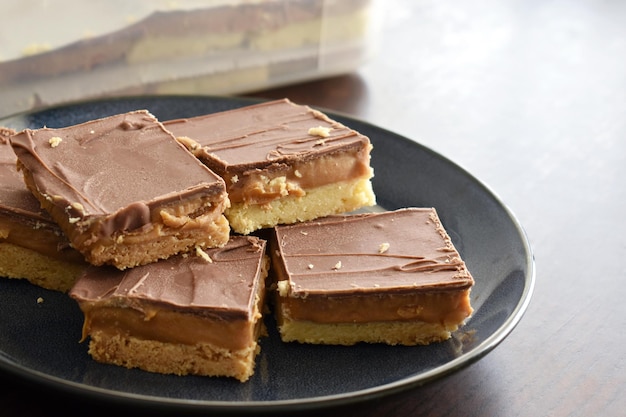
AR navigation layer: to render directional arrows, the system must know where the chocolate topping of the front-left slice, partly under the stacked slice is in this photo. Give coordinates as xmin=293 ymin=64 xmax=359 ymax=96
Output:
xmin=69 ymin=236 xmax=266 ymax=320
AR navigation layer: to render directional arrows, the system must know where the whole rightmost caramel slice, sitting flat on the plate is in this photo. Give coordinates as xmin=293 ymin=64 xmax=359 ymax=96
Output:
xmin=271 ymin=208 xmax=474 ymax=345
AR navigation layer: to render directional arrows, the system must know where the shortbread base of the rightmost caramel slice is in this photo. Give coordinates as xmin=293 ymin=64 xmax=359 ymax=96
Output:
xmin=279 ymin=319 xmax=458 ymax=346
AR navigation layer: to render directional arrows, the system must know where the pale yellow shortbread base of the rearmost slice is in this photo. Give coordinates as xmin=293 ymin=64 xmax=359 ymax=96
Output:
xmin=224 ymin=178 xmax=376 ymax=235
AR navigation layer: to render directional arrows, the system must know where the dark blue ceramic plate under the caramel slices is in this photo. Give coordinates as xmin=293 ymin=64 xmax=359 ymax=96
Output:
xmin=0 ymin=97 xmax=535 ymax=411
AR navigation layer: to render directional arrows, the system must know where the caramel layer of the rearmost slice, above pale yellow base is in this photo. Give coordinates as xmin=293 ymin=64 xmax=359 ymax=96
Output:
xmin=221 ymin=149 xmax=373 ymax=204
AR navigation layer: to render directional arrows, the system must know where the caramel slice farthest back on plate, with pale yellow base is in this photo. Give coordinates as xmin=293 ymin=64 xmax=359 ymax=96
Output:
xmin=164 ymin=99 xmax=375 ymax=234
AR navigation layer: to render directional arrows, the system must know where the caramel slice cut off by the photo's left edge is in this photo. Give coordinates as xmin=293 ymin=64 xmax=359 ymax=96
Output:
xmin=0 ymin=127 xmax=87 ymax=292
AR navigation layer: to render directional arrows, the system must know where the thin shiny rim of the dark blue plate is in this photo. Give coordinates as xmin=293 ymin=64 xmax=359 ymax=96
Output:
xmin=0 ymin=94 xmax=536 ymax=413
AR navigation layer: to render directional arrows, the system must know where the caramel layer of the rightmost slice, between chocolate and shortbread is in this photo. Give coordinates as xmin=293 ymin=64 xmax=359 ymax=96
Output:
xmin=277 ymin=289 xmax=473 ymax=325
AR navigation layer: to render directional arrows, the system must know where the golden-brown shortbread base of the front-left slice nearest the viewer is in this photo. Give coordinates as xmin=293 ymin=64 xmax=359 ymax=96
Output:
xmin=89 ymin=332 xmax=261 ymax=382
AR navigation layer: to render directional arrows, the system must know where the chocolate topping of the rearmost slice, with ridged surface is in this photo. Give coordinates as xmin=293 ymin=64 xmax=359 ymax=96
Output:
xmin=164 ymin=99 xmax=370 ymax=175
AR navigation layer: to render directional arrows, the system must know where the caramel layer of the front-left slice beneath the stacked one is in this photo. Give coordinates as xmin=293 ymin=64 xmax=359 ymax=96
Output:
xmin=81 ymin=303 xmax=261 ymax=350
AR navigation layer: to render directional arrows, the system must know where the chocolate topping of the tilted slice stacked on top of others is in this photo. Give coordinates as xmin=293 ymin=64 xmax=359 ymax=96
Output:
xmin=11 ymin=110 xmax=225 ymax=235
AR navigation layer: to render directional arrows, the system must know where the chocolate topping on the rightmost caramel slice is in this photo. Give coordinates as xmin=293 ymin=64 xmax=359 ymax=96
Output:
xmin=274 ymin=208 xmax=474 ymax=298
